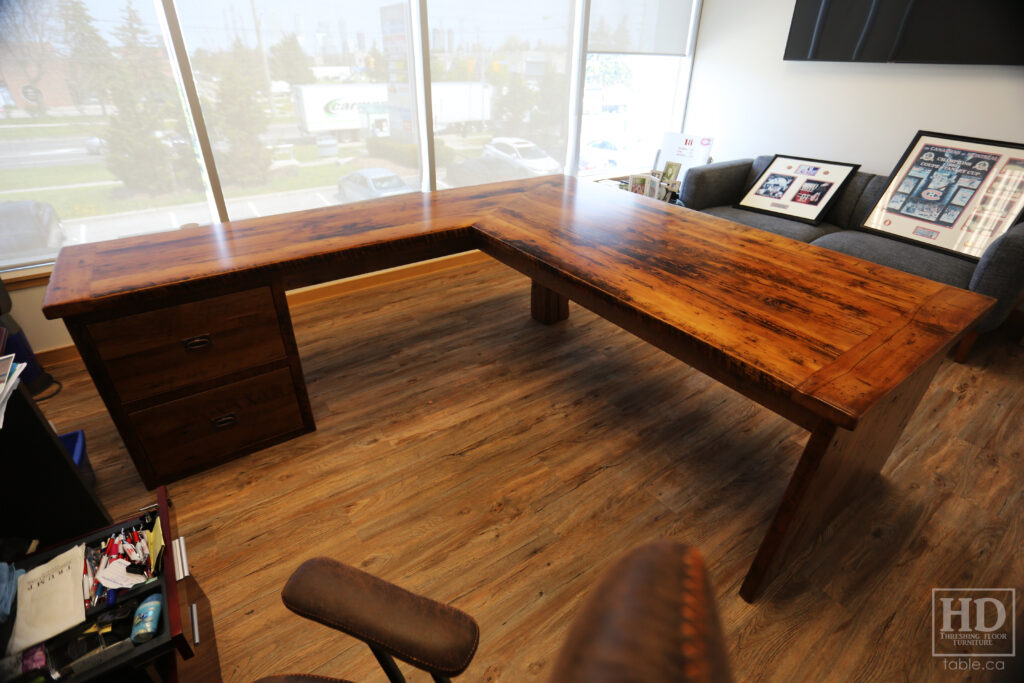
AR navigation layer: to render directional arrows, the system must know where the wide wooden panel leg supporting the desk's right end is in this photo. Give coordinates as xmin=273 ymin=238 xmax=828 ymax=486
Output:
xmin=739 ymin=353 xmax=945 ymax=602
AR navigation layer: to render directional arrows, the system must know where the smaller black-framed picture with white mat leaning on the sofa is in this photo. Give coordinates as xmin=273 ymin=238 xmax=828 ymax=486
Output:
xmin=736 ymin=155 xmax=860 ymax=225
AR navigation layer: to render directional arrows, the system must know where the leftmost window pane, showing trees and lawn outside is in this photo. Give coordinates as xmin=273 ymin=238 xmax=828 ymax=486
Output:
xmin=0 ymin=0 xmax=216 ymax=268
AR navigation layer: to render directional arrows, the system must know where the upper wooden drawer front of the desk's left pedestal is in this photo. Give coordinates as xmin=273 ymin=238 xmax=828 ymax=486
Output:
xmin=88 ymin=287 xmax=285 ymax=403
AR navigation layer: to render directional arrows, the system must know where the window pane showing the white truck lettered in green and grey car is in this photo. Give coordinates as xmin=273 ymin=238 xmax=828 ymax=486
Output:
xmin=175 ymin=0 xmax=420 ymax=219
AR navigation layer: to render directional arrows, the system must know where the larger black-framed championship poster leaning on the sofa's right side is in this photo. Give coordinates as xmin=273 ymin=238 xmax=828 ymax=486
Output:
xmin=863 ymin=130 xmax=1024 ymax=259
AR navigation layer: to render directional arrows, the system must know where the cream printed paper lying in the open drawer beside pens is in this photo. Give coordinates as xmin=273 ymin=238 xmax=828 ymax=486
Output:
xmin=7 ymin=545 xmax=85 ymax=654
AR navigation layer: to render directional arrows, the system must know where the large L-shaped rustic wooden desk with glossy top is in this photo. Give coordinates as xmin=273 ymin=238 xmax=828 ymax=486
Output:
xmin=43 ymin=176 xmax=992 ymax=600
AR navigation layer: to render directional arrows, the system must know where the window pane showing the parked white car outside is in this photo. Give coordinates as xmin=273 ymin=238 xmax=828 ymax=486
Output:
xmin=427 ymin=0 xmax=573 ymax=187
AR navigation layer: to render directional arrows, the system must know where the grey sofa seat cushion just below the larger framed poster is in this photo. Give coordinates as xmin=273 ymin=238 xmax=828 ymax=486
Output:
xmin=811 ymin=230 xmax=975 ymax=289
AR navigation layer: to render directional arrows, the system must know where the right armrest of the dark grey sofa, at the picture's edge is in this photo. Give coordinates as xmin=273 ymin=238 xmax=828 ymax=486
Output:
xmin=971 ymin=223 xmax=1024 ymax=333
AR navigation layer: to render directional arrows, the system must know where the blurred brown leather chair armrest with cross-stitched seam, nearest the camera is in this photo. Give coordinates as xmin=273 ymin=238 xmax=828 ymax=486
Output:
xmin=549 ymin=542 xmax=732 ymax=683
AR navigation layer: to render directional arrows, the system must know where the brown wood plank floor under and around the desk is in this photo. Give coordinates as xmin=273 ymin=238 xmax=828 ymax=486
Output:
xmin=36 ymin=261 xmax=1024 ymax=682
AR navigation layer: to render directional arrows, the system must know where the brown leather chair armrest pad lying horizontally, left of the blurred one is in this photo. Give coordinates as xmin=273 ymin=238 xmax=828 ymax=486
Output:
xmin=282 ymin=557 xmax=480 ymax=676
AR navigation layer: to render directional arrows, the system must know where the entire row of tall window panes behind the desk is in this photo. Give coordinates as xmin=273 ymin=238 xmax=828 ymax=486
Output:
xmin=0 ymin=0 xmax=694 ymax=270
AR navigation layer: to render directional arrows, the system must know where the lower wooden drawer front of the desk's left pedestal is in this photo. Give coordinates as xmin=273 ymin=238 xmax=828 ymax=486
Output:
xmin=128 ymin=368 xmax=304 ymax=481
